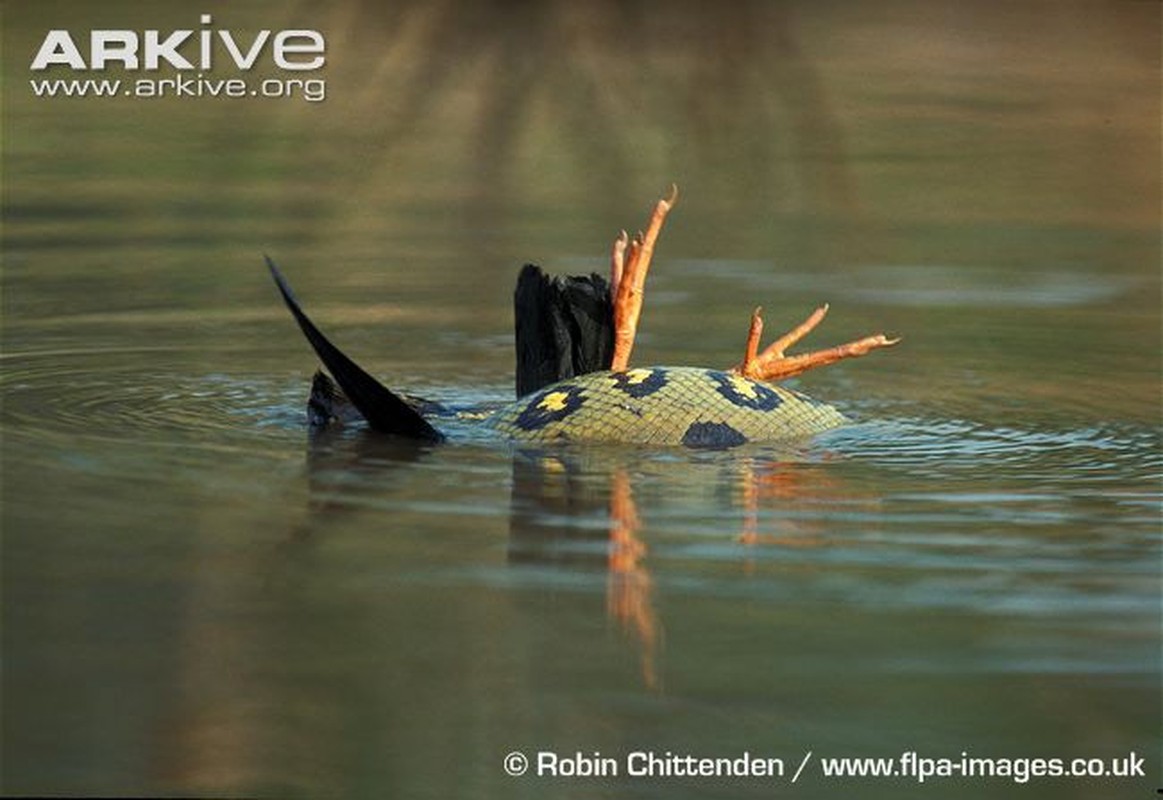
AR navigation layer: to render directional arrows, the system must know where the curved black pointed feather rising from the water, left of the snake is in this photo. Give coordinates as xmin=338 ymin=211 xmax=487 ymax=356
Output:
xmin=266 ymin=257 xmax=444 ymax=442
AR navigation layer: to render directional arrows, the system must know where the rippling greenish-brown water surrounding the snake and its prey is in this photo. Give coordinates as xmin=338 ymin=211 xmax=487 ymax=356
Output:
xmin=0 ymin=2 xmax=1163 ymax=798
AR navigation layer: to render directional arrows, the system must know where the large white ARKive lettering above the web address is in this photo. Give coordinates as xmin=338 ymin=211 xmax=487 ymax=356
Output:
xmin=30 ymin=14 xmax=327 ymax=71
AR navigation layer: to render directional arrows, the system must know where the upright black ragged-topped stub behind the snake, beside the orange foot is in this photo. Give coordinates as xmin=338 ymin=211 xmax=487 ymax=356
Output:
xmin=513 ymin=264 xmax=614 ymax=398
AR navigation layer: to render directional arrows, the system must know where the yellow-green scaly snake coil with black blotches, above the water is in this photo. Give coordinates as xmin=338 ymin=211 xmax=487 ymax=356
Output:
xmin=483 ymin=366 xmax=846 ymax=448
